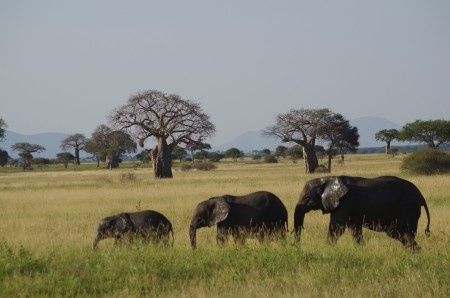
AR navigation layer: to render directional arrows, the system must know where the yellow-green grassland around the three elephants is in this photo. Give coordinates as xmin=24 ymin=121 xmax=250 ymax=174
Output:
xmin=0 ymin=155 xmax=450 ymax=297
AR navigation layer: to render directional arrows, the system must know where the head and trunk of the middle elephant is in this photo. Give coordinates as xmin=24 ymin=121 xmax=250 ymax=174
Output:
xmin=189 ymin=196 xmax=230 ymax=249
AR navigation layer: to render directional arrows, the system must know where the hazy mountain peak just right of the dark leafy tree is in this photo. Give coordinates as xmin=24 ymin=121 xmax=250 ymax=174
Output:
xmin=350 ymin=117 xmax=401 ymax=147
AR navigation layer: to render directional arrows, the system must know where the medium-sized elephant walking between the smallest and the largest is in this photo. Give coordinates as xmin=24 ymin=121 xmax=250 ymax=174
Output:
xmin=189 ymin=191 xmax=287 ymax=248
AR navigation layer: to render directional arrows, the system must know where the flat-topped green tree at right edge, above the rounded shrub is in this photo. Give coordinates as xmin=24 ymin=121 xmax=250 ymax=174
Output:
xmin=399 ymin=120 xmax=450 ymax=149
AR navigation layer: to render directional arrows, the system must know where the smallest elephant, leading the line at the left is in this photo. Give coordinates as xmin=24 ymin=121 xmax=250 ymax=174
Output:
xmin=93 ymin=210 xmax=174 ymax=249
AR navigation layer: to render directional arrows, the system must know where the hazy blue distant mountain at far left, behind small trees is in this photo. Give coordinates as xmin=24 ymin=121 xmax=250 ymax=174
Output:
xmin=0 ymin=130 xmax=68 ymax=158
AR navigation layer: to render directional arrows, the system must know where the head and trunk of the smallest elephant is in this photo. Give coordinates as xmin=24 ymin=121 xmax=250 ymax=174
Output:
xmin=92 ymin=213 xmax=133 ymax=249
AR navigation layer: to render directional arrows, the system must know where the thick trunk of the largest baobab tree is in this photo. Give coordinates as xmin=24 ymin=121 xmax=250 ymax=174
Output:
xmin=152 ymin=137 xmax=173 ymax=178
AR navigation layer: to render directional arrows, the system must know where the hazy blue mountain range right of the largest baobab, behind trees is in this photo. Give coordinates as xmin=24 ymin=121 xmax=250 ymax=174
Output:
xmin=213 ymin=117 xmax=400 ymax=152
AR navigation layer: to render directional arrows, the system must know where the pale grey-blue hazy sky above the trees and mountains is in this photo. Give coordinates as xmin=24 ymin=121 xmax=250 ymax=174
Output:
xmin=0 ymin=0 xmax=450 ymax=144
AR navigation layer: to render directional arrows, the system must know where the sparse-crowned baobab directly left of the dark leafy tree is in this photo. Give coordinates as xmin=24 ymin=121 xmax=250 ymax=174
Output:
xmin=263 ymin=109 xmax=331 ymax=173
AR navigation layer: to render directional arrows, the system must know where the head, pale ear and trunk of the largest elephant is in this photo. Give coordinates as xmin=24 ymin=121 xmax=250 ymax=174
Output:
xmin=294 ymin=177 xmax=348 ymax=239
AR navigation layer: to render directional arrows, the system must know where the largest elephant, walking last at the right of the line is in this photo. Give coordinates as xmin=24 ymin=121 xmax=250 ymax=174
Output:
xmin=294 ymin=176 xmax=430 ymax=249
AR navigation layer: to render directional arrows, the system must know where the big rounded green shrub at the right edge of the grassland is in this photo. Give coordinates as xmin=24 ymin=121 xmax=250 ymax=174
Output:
xmin=401 ymin=149 xmax=450 ymax=175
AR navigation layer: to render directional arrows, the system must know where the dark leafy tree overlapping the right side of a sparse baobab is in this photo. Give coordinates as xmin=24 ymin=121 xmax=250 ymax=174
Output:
xmin=318 ymin=113 xmax=359 ymax=173
